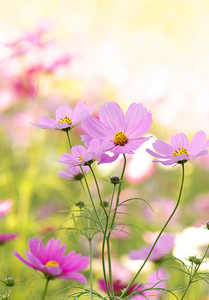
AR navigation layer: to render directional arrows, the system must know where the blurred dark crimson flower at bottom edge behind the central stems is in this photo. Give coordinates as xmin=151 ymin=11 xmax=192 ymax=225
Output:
xmin=98 ymin=279 xmax=145 ymax=300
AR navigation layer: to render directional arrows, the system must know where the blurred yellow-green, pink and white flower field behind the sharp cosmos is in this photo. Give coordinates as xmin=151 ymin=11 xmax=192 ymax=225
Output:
xmin=0 ymin=0 xmax=209 ymax=300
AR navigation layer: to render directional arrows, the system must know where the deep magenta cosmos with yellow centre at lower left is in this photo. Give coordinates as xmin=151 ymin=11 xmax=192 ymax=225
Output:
xmin=13 ymin=237 xmax=89 ymax=283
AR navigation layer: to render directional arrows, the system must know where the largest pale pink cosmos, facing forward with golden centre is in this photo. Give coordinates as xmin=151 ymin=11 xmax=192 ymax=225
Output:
xmin=81 ymin=102 xmax=152 ymax=155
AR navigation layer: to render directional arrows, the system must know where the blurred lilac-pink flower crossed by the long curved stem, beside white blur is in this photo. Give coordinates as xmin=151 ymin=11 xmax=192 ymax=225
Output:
xmin=130 ymin=233 xmax=175 ymax=261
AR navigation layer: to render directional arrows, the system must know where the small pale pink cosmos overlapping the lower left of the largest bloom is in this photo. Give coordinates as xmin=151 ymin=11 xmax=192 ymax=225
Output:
xmin=59 ymin=138 xmax=108 ymax=166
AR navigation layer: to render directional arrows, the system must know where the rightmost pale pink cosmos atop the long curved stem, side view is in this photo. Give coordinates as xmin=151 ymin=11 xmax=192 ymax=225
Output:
xmin=146 ymin=130 xmax=209 ymax=165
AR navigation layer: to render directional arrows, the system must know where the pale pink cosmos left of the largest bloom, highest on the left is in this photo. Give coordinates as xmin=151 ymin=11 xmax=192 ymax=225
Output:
xmin=31 ymin=101 xmax=93 ymax=130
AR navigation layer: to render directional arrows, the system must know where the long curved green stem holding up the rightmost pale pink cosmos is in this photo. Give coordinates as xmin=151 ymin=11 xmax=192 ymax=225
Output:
xmin=120 ymin=163 xmax=184 ymax=297
